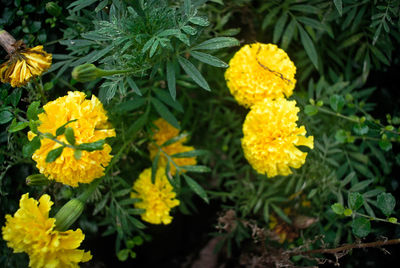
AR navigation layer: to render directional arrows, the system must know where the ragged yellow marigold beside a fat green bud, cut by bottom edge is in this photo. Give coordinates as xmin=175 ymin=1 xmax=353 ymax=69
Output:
xmin=2 ymin=193 xmax=92 ymax=268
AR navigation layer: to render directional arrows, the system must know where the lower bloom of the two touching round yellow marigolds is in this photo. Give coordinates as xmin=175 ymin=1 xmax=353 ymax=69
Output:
xmin=242 ymin=98 xmax=314 ymax=177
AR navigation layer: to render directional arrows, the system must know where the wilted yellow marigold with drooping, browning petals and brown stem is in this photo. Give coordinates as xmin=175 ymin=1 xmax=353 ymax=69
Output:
xmin=0 ymin=46 xmax=52 ymax=87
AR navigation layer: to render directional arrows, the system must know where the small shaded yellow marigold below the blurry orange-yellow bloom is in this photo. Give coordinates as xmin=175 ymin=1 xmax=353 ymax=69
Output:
xmin=131 ymin=168 xmax=179 ymax=224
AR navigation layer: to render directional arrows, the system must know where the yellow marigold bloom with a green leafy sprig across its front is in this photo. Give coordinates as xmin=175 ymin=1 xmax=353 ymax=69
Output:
xmin=28 ymin=91 xmax=115 ymax=187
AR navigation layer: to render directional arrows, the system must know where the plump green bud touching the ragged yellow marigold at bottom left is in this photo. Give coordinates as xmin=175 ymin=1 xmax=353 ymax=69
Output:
xmin=54 ymin=199 xmax=84 ymax=231
